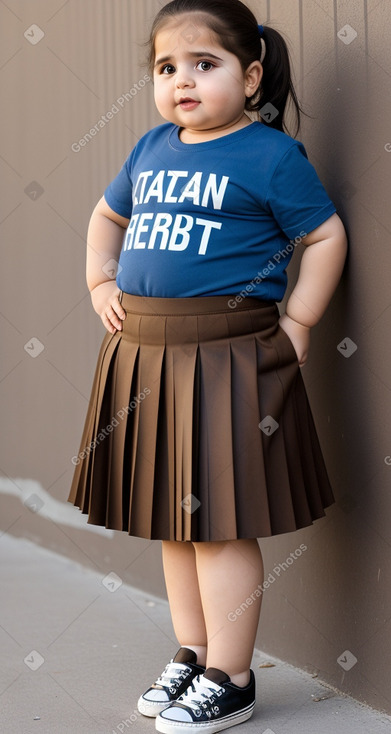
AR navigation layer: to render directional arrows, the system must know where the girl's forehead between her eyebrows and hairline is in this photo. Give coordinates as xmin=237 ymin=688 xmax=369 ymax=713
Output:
xmin=155 ymin=13 xmax=224 ymax=57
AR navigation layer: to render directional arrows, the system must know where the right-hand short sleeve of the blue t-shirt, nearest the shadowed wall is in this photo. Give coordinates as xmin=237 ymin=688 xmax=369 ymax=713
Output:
xmin=266 ymin=142 xmax=336 ymax=239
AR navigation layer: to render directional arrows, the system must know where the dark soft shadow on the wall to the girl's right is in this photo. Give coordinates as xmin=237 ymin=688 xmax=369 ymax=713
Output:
xmin=296 ymin=28 xmax=391 ymax=712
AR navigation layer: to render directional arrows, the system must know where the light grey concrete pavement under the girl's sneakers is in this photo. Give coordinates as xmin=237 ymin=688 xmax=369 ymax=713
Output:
xmin=0 ymin=535 xmax=391 ymax=734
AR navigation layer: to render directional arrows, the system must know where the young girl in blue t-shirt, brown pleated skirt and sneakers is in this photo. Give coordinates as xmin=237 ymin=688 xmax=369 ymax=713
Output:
xmin=69 ymin=0 xmax=346 ymax=734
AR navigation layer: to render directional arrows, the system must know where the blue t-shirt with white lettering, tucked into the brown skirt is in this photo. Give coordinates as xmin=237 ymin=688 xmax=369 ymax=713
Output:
xmin=104 ymin=122 xmax=336 ymax=301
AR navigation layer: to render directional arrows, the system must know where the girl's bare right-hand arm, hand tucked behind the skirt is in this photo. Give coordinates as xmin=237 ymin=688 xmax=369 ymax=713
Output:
xmin=280 ymin=214 xmax=347 ymax=366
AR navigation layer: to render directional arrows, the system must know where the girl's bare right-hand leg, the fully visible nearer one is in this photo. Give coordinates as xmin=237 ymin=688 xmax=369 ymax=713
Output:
xmin=194 ymin=538 xmax=263 ymax=686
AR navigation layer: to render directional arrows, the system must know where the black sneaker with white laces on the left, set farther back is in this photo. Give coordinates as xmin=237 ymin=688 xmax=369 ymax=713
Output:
xmin=137 ymin=647 xmax=205 ymax=716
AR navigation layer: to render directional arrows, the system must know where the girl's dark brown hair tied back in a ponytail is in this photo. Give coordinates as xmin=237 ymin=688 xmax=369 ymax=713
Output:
xmin=148 ymin=0 xmax=303 ymax=135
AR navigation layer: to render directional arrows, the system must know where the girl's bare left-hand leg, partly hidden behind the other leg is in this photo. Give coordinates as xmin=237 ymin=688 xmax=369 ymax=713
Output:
xmin=162 ymin=540 xmax=207 ymax=665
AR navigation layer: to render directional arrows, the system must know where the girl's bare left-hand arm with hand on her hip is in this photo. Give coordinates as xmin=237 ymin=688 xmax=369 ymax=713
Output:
xmin=86 ymin=197 xmax=129 ymax=334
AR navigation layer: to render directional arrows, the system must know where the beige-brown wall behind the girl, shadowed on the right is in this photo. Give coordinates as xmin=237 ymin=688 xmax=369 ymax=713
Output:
xmin=0 ymin=0 xmax=391 ymax=713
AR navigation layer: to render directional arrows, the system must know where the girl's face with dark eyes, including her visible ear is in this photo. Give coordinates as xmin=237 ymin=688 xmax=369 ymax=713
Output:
xmin=154 ymin=16 xmax=262 ymax=142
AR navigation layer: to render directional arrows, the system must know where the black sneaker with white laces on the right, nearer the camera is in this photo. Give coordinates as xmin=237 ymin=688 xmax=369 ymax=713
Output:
xmin=156 ymin=668 xmax=255 ymax=734
